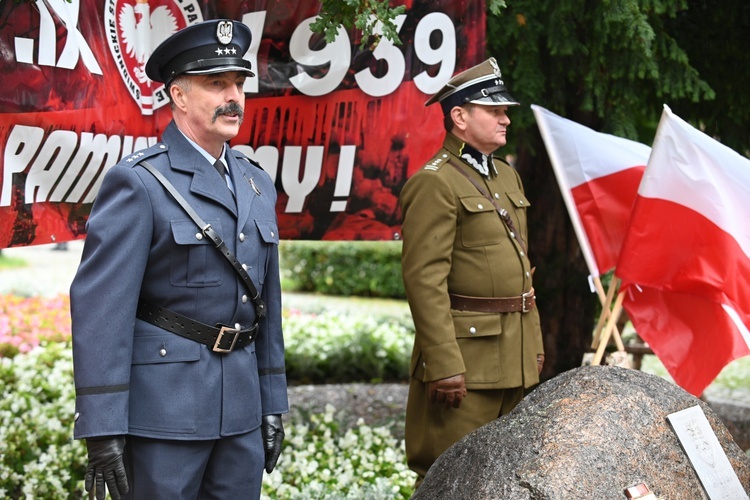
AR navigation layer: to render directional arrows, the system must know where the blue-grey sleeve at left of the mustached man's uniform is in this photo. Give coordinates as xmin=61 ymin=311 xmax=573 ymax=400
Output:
xmin=70 ymin=166 xmax=153 ymax=439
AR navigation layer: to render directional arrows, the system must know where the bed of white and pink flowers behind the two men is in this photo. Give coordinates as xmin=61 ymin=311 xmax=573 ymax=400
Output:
xmin=0 ymin=295 xmax=415 ymax=499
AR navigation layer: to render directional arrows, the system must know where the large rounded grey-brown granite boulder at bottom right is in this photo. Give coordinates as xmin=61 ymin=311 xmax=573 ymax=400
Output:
xmin=413 ymin=366 xmax=750 ymax=500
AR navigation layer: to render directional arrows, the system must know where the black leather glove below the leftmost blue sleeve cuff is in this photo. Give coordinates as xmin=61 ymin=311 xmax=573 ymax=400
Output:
xmin=84 ymin=436 xmax=129 ymax=500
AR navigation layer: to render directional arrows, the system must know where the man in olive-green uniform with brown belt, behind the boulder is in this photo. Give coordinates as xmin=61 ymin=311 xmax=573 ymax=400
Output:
xmin=400 ymin=58 xmax=544 ymax=484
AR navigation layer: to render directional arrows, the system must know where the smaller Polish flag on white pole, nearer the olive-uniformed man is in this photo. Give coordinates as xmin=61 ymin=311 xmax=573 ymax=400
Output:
xmin=531 ymin=104 xmax=651 ymax=277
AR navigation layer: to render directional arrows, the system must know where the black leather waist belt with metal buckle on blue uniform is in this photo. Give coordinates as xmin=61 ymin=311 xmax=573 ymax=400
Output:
xmin=136 ymin=299 xmax=258 ymax=353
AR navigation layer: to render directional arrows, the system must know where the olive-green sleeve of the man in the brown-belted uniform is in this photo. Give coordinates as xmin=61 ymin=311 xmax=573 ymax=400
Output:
xmin=401 ymin=170 xmax=466 ymax=381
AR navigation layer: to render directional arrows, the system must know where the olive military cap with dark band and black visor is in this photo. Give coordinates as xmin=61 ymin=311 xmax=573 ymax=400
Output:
xmin=425 ymin=57 xmax=521 ymax=115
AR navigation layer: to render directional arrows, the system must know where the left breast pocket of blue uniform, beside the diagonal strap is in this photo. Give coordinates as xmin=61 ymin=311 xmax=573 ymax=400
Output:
xmin=169 ymin=220 xmax=222 ymax=287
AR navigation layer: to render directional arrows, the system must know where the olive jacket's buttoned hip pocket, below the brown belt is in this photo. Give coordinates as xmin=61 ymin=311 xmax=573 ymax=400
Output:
xmin=451 ymin=311 xmax=503 ymax=384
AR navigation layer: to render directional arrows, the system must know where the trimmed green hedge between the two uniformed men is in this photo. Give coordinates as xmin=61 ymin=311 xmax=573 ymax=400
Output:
xmin=279 ymin=241 xmax=406 ymax=299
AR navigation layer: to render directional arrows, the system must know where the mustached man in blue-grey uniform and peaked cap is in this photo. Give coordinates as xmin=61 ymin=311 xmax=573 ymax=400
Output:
xmin=71 ymin=20 xmax=288 ymax=499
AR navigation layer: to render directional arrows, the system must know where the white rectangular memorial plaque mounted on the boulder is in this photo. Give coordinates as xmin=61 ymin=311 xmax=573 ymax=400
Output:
xmin=667 ymin=405 xmax=748 ymax=500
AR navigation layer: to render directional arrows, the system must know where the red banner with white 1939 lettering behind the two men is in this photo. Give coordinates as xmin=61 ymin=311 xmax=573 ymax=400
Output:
xmin=0 ymin=0 xmax=485 ymax=248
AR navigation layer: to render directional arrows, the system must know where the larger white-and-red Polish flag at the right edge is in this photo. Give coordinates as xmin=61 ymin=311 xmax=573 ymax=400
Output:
xmin=615 ymin=106 xmax=750 ymax=396
